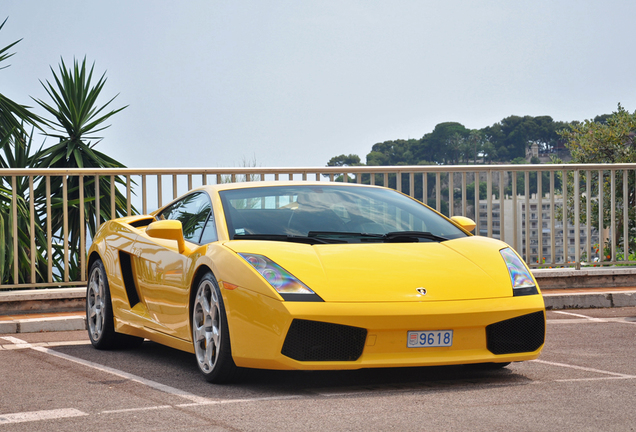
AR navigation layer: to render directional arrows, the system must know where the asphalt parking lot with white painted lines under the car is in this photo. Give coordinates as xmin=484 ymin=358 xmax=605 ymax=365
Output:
xmin=0 ymin=308 xmax=636 ymax=432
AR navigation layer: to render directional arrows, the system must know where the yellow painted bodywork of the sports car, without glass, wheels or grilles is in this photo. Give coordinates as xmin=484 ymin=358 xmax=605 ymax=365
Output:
xmin=88 ymin=183 xmax=545 ymax=369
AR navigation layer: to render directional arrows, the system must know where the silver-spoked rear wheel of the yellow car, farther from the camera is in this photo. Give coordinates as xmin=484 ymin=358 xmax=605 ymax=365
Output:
xmin=86 ymin=260 xmax=144 ymax=350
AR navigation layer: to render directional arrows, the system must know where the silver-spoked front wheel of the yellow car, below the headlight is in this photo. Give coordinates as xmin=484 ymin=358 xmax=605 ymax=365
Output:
xmin=192 ymin=273 xmax=238 ymax=383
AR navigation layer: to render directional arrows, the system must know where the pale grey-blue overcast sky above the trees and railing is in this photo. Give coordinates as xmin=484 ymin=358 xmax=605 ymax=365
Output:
xmin=0 ymin=0 xmax=636 ymax=168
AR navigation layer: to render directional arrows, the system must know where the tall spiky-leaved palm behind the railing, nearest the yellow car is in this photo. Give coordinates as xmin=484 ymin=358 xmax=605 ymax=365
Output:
xmin=34 ymin=58 xmax=132 ymax=278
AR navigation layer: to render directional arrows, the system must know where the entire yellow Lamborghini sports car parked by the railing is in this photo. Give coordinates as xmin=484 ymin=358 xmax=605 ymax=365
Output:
xmin=86 ymin=182 xmax=545 ymax=383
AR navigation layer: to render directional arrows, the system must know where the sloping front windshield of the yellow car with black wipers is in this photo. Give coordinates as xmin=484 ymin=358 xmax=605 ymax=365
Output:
xmin=219 ymin=185 xmax=467 ymax=244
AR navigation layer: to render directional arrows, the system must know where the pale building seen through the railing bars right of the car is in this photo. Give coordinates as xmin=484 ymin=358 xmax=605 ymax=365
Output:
xmin=478 ymin=195 xmax=599 ymax=264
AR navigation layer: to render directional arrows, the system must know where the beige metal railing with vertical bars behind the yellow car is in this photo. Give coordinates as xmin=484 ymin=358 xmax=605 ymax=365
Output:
xmin=0 ymin=164 xmax=636 ymax=289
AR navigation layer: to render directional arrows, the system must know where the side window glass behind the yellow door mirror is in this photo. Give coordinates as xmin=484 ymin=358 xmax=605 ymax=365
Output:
xmin=157 ymin=192 xmax=216 ymax=243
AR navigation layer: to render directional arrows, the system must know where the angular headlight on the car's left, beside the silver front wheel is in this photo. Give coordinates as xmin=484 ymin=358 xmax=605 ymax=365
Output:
xmin=239 ymin=253 xmax=323 ymax=301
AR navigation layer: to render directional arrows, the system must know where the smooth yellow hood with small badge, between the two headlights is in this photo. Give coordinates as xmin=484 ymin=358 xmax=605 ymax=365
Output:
xmin=225 ymin=237 xmax=512 ymax=302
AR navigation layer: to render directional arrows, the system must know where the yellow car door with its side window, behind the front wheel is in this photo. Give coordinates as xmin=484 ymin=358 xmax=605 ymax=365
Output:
xmin=134 ymin=191 xmax=216 ymax=339
